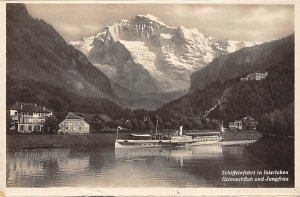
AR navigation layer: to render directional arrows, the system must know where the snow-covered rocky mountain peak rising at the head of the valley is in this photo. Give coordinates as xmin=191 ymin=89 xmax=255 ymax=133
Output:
xmin=70 ymin=14 xmax=260 ymax=93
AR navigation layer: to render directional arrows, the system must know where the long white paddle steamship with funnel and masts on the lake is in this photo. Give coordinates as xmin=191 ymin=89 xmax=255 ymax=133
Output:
xmin=115 ymin=121 xmax=222 ymax=148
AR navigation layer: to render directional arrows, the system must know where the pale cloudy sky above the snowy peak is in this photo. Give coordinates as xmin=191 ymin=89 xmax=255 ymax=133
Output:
xmin=26 ymin=3 xmax=294 ymax=42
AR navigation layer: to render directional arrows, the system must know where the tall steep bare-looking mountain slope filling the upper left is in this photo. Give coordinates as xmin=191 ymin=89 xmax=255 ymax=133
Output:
xmin=6 ymin=4 xmax=123 ymax=111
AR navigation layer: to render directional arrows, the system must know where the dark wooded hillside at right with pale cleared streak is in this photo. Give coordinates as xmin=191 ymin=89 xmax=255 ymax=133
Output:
xmin=157 ymin=35 xmax=294 ymax=136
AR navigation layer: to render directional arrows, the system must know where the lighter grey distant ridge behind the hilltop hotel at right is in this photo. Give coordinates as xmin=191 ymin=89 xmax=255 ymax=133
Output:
xmin=191 ymin=35 xmax=294 ymax=89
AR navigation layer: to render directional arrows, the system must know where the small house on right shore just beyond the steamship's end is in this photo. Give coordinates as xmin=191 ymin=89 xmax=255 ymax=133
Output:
xmin=229 ymin=115 xmax=258 ymax=130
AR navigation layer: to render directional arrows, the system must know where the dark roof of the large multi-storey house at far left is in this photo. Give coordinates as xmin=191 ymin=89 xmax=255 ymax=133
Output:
xmin=10 ymin=102 xmax=52 ymax=113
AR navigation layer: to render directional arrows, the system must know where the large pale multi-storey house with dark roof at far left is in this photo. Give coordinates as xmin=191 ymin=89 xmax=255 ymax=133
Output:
xmin=9 ymin=102 xmax=52 ymax=133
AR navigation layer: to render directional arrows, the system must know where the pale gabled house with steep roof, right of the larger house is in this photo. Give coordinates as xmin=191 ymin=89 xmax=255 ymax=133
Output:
xmin=58 ymin=112 xmax=90 ymax=134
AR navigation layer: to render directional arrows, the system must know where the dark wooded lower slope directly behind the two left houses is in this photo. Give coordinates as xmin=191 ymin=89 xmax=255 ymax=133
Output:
xmin=6 ymin=77 xmax=129 ymax=118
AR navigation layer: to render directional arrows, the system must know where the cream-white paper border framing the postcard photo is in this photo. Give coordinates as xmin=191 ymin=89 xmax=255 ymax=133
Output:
xmin=0 ymin=0 xmax=300 ymax=197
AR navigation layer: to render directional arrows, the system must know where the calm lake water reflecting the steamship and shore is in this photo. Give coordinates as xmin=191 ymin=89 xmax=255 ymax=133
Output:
xmin=6 ymin=144 xmax=292 ymax=188
